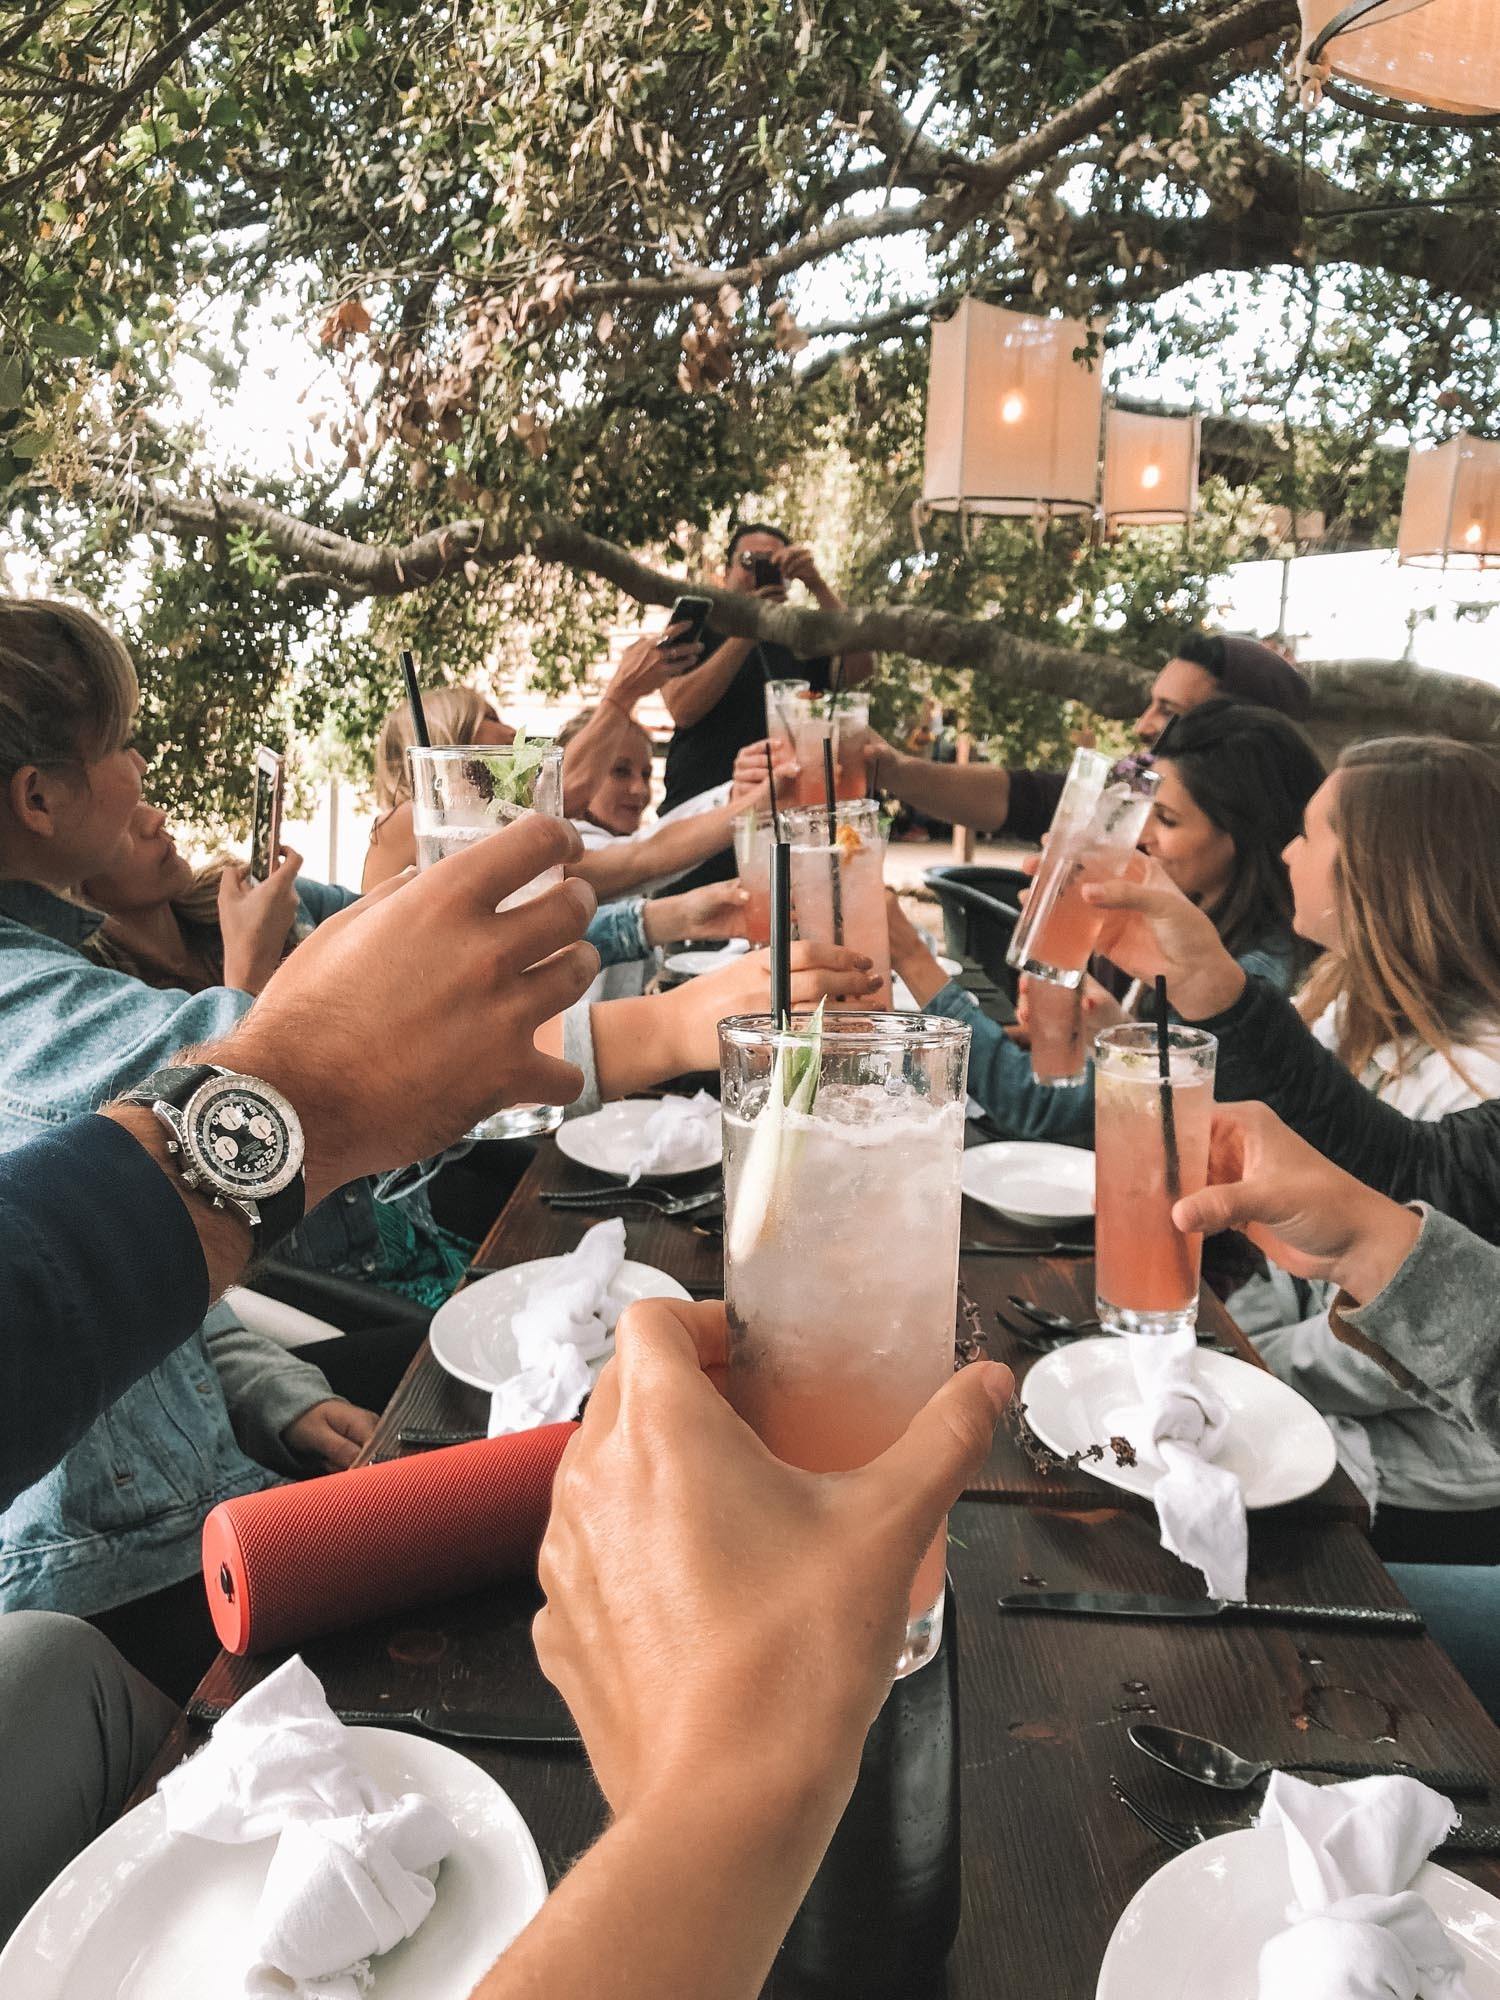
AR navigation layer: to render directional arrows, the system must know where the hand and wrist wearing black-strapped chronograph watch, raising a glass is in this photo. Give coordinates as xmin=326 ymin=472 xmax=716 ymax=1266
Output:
xmin=106 ymin=814 xmax=598 ymax=1296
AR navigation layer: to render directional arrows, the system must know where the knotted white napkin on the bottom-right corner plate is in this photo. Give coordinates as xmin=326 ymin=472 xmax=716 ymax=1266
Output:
xmin=1260 ymin=1770 xmax=1466 ymax=2000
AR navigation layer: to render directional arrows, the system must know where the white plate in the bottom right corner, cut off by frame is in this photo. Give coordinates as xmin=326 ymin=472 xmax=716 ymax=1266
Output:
xmin=1094 ymin=1826 xmax=1500 ymax=2000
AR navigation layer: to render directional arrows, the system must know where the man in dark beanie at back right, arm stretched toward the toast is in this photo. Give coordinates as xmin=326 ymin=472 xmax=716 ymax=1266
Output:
xmin=866 ymin=632 xmax=1312 ymax=840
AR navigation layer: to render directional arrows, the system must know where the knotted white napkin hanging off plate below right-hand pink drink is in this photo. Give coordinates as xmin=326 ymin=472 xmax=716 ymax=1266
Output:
xmin=1110 ymin=1332 xmax=1248 ymax=1598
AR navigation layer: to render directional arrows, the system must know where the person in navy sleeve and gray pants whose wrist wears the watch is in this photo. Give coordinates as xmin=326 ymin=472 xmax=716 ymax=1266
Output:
xmin=0 ymin=820 xmax=596 ymax=1944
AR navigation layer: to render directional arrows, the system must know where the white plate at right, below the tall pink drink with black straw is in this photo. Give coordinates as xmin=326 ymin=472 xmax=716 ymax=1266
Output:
xmin=1020 ymin=1334 xmax=1336 ymax=1508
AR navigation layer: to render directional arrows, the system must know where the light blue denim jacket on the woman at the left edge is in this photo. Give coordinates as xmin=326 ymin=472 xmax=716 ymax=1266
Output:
xmin=0 ymin=882 xmax=412 ymax=1614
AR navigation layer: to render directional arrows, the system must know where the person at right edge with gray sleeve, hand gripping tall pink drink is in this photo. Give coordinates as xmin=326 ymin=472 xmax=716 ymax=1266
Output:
xmin=1174 ymin=1104 xmax=1500 ymax=1720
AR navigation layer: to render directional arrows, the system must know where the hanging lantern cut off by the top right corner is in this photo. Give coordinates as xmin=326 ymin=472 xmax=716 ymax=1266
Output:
xmin=1298 ymin=0 xmax=1500 ymax=118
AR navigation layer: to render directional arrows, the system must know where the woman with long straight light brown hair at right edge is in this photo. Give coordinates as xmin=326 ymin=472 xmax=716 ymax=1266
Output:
xmin=1096 ymin=736 xmax=1500 ymax=1562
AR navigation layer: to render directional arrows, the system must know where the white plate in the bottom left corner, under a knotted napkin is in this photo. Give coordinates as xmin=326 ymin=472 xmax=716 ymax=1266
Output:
xmin=0 ymin=1728 xmax=546 ymax=2000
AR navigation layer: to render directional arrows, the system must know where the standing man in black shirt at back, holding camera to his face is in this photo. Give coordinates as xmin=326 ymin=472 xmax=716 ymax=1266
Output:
xmin=662 ymin=522 xmax=874 ymax=832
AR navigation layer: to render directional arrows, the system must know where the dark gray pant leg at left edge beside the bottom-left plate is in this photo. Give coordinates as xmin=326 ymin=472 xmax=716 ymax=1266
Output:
xmin=0 ymin=1612 xmax=176 ymax=1944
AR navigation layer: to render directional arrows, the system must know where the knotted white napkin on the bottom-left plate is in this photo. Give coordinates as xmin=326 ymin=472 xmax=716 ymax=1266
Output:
xmin=160 ymin=1656 xmax=458 ymax=2000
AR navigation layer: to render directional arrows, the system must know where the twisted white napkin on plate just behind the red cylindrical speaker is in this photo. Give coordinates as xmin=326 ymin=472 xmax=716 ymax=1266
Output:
xmin=490 ymin=1216 xmax=624 ymax=1438
